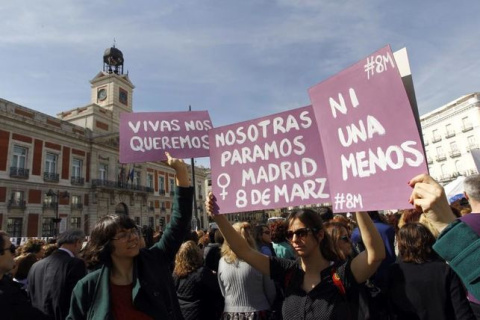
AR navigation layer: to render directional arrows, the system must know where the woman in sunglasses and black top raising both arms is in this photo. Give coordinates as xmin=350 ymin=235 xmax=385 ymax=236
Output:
xmin=206 ymin=193 xmax=385 ymax=320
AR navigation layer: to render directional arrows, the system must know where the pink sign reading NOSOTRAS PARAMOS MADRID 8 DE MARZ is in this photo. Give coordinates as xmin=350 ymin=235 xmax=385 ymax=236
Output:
xmin=209 ymin=106 xmax=330 ymax=213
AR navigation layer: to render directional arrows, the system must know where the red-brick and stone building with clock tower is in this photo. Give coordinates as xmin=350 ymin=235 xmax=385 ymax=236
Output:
xmin=0 ymin=47 xmax=208 ymax=237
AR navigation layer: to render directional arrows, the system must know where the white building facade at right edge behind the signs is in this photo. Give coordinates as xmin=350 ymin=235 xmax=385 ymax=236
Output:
xmin=420 ymin=92 xmax=480 ymax=184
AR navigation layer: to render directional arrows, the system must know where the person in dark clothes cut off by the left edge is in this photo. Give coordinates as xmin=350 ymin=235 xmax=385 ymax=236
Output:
xmin=0 ymin=230 xmax=50 ymax=320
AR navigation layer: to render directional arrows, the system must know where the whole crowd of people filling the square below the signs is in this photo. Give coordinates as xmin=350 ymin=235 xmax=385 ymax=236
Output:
xmin=0 ymin=154 xmax=480 ymax=320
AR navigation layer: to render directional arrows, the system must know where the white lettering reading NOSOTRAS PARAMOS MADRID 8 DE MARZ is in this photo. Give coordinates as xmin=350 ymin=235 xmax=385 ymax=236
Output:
xmin=214 ymin=110 xmax=330 ymax=209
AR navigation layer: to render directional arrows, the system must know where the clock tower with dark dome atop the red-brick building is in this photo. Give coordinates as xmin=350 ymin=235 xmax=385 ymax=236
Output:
xmin=90 ymin=45 xmax=135 ymax=121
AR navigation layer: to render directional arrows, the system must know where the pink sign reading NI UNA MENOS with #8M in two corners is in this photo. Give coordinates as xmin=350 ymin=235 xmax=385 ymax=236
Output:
xmin=309 ymin=46 xmax=427 ymax=212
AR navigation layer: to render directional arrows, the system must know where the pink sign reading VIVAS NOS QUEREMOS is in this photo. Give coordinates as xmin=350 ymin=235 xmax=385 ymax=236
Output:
xmin=120 ymin=111 xmax=212 ymax=163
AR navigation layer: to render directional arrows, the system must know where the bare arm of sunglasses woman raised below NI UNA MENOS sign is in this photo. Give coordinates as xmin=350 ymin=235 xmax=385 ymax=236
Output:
xmin=351 ymin=212 xmax=385 ymax=283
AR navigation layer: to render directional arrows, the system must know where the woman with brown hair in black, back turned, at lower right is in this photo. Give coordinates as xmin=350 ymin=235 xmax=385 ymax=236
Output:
xmin=387 ymin=222 xmax=475 ymax=320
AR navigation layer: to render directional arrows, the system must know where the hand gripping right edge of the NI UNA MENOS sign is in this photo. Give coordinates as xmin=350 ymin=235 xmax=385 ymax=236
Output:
xmin=408 ymin=174 xmax=455 ymax=233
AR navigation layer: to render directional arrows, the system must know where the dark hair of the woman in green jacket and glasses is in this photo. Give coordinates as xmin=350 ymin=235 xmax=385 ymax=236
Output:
xmin=82 ymin=214 xmax=137 ymax=270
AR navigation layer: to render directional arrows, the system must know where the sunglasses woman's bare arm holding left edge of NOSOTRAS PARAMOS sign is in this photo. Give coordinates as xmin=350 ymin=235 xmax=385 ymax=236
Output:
xmin=205 ymin=192 xmax=270 ymax=276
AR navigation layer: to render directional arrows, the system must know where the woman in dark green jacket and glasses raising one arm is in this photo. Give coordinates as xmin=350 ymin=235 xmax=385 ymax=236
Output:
xmin=67 ymin=153 xmax=193 ymax=320
